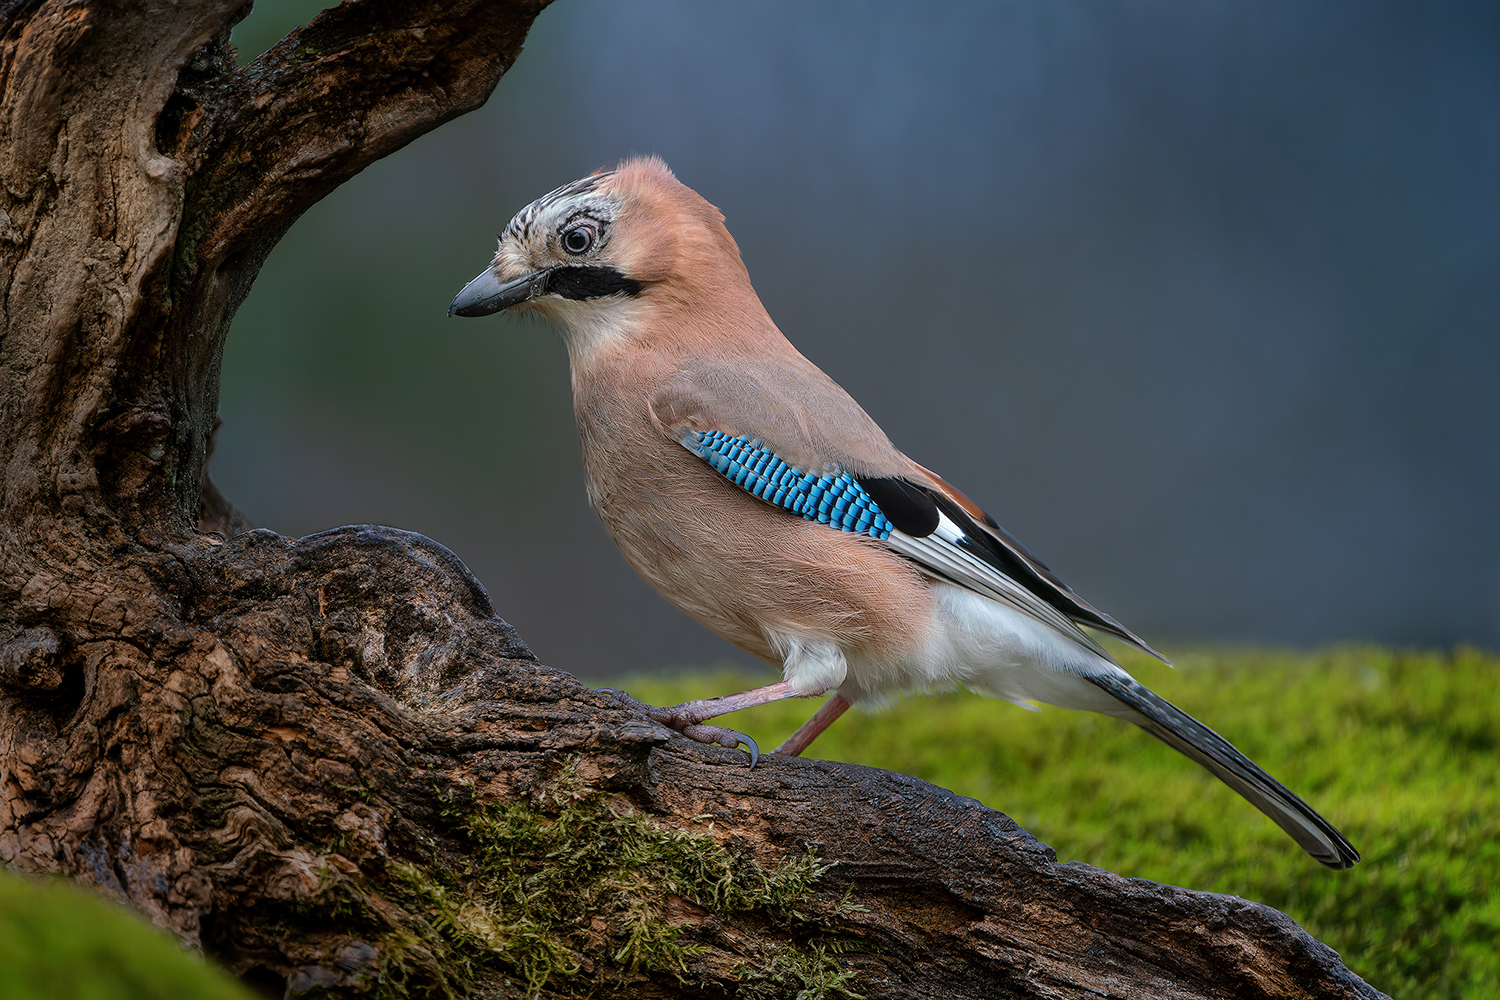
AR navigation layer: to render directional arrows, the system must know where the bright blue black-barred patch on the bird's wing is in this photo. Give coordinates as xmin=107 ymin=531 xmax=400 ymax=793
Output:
xmin=683 ymin=430 xmax=891 ymax=540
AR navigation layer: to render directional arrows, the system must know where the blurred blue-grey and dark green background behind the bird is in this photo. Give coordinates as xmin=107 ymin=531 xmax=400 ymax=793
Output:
xmin=212 ymin=0 xmax=1500 ymax=678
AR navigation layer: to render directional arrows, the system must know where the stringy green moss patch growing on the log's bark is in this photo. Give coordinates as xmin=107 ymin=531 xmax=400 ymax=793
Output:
xmin=392 ymin=765 xmax=855 ymax=997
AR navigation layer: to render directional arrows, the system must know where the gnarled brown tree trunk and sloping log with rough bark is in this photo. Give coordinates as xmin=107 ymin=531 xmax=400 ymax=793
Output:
xmin=0 ymin=0 xmax=1380 ymax=997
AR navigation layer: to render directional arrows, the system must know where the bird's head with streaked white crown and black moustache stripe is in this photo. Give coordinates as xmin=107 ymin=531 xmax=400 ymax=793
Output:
xmin=449 ymin=156 xmax=764 ymax=359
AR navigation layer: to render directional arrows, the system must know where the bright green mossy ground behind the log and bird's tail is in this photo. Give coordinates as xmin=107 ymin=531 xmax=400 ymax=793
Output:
xmin=612 ymin=648 xmax=1500 ymax=1000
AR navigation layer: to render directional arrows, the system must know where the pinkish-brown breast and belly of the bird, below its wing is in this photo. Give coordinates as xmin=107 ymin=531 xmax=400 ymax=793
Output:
xmin=575 ymin=347 xmax=932 ymax=663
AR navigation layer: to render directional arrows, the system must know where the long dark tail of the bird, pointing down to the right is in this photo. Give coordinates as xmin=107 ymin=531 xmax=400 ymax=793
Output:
xmin=1089 ymin=675 xmax=1359 ymax=868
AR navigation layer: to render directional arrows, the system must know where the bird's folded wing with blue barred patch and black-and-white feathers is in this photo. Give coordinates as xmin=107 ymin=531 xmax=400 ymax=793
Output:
xmin=651 ymin=355 xmax=1163 ymax=660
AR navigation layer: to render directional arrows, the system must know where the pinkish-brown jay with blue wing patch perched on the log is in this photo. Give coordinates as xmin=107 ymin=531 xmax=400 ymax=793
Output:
xmin=449 ymin=156 xmax=1359 ymax=870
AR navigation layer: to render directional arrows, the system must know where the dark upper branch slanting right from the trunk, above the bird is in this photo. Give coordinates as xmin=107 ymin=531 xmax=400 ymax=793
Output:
xmin=182 ymin=0 xmax=549 ymax=274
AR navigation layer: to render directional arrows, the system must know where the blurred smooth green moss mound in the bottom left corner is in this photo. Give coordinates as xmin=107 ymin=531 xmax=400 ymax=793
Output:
xmin=0 ymin=871 xmax=251 ymax=1000
